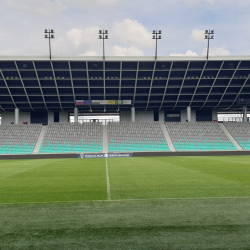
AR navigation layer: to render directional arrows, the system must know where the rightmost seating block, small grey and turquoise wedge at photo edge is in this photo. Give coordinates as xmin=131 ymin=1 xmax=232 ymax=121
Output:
xmin=223 ymin=122 xmax=250 ymax=150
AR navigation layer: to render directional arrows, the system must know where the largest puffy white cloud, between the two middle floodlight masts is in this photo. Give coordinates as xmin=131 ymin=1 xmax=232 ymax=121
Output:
xmin=113 ymin=19 xmax=154 ymax=47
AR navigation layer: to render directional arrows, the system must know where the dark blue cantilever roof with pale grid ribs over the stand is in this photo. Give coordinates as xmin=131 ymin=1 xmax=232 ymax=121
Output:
xmin=0 ymin=56 xmax=250 ymax=112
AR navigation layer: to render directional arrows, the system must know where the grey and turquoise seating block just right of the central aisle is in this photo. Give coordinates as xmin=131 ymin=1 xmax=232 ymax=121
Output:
xmin=108 ymin=122 xmax=170 ymax=152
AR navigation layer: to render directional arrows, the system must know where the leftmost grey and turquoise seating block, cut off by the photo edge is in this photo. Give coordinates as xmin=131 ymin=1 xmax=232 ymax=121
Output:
xmin=0 ymin=124 xmax=42 ymax=154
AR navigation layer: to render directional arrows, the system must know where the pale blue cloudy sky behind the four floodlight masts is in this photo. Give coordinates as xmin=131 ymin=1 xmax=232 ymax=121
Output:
xmin=0 ymin=0 xmax=250 ymax=56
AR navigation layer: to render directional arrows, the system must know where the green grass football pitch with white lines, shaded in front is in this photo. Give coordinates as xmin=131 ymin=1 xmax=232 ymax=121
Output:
xmin=0 ymin=156 xmax=250 ymax=250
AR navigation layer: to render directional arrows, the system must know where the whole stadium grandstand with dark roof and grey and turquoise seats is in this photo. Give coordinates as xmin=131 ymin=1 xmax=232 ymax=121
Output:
xmin=0 ymin=56 xmax=250 ymax=154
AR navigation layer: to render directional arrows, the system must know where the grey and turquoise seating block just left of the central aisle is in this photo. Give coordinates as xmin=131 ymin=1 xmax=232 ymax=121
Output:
xmin=39 ymin=123 xmax=103 ymax=153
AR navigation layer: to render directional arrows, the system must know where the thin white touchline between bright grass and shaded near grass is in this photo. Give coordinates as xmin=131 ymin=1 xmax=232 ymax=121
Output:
xmin=0 ymin=196 xmax=250 ymax=206
